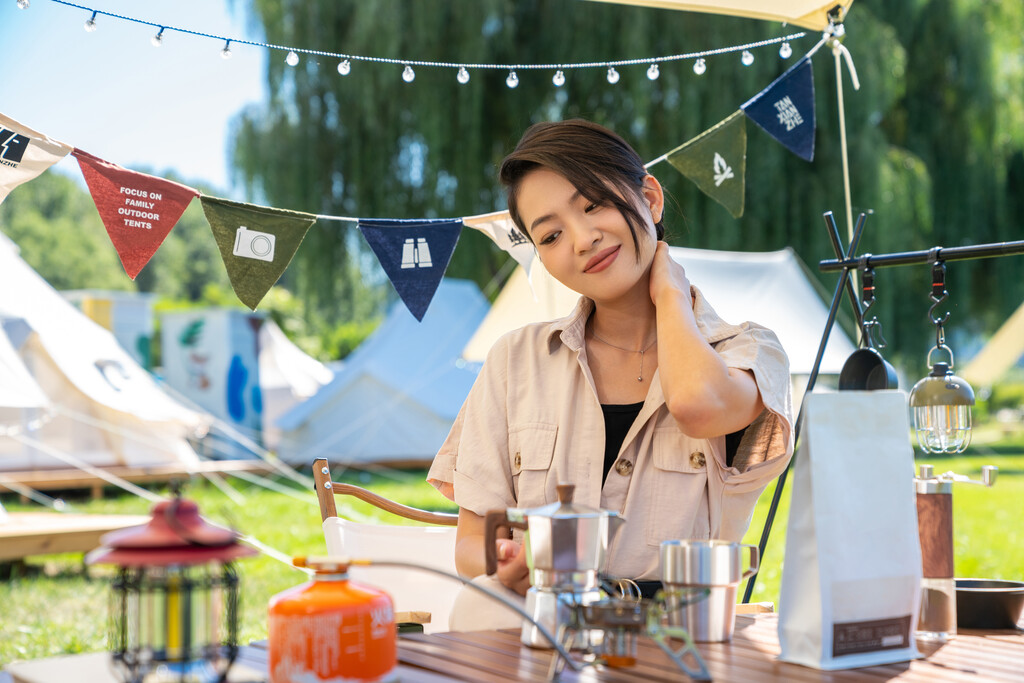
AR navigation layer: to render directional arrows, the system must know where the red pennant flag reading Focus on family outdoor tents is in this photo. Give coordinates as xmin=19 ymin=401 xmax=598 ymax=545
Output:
xmin=72 ymin=150 xmax=199 ymax=280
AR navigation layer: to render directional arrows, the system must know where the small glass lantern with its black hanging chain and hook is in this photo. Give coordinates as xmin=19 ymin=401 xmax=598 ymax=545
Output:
xmin=910 ymin=261 xmax=974 ymax=453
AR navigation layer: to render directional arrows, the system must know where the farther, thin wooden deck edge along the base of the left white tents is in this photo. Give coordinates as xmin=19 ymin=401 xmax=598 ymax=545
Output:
xmin=0 ymin=460 xmax=273 ymax=499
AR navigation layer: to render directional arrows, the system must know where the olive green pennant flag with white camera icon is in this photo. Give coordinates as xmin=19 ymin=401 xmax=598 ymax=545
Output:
xmin=201 ymin=197 xmax=316 ymax=310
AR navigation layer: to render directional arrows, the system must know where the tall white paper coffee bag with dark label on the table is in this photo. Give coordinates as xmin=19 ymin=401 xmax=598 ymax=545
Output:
xmin=778 ymin=391 xmax=922 ymax=670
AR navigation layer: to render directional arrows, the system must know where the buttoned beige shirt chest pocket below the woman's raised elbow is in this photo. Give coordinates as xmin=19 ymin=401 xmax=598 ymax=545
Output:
xmin=646 ymin=427 xmax=712 ymax=546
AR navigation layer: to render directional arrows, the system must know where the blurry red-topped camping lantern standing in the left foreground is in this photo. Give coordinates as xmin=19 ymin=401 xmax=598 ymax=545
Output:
xmin=86 ymin=496 xmax=256 ymax=683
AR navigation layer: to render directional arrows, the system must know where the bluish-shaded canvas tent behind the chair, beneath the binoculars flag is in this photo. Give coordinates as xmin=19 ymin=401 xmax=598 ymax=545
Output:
xmin=278 ymin=279 xmax=488 ymax=465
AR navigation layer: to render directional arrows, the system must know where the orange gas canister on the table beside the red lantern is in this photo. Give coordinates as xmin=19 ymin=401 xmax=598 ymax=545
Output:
xmin=267 ymin=558 xmax=397 ymax=683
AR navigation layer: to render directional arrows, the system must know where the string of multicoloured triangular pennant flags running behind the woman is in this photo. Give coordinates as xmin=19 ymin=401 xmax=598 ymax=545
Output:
xmin=0 ymin=34 xmax=831 ymax=321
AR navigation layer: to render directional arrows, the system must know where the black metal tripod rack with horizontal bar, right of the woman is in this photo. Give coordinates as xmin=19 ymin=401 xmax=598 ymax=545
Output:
xmin=743 ymin=211 xmax=1024 ymax=602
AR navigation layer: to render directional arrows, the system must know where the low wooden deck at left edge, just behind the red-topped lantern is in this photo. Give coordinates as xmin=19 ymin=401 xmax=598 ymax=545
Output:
xmin=0 ymin=512 xmax=148 ymax=562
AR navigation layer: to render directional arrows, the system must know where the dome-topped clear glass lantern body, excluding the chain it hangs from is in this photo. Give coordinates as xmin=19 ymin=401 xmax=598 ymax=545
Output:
xmin=910 ymin=362 xmax=974 ymax=453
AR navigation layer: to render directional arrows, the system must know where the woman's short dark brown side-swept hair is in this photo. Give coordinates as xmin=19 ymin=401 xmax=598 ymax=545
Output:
xmin=498 ymin=119 xmax=665 ymax=258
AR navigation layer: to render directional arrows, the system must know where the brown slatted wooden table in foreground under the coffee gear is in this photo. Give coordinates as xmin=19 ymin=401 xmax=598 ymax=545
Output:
xmin=7 ymin=614 xmax=1024 ymax=683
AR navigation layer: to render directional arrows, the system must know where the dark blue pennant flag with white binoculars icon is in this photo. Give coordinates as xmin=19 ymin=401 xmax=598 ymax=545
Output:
xmin=359 ymin=218 xmax=462 ymax=321
